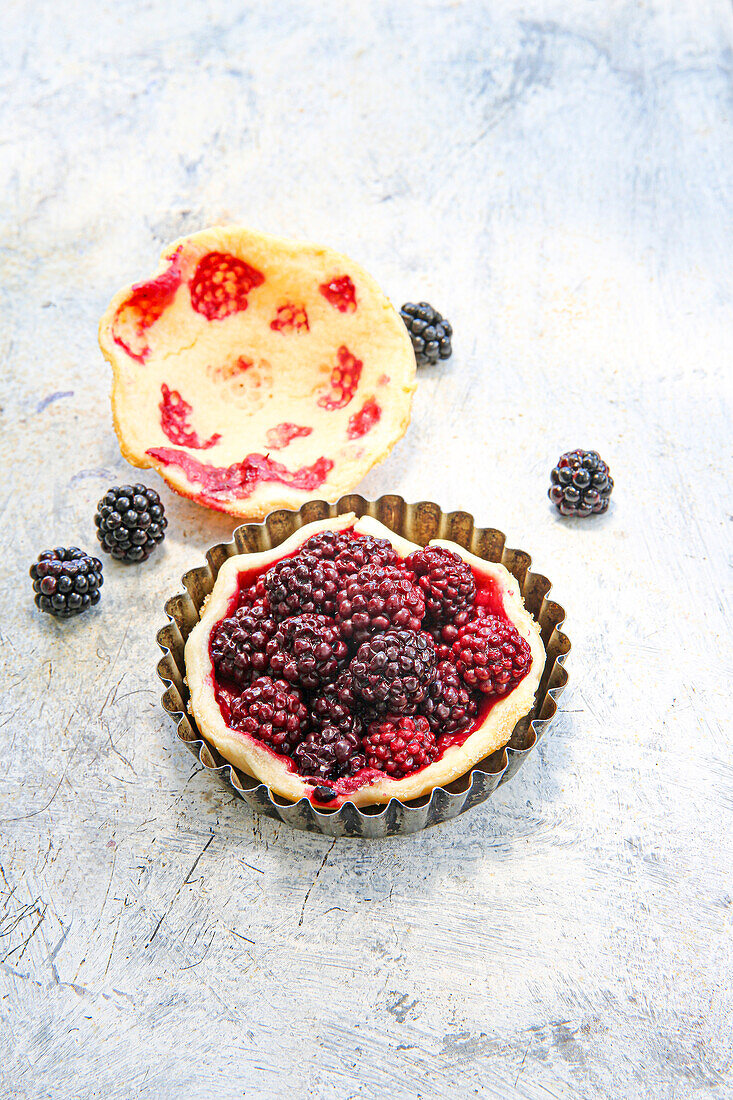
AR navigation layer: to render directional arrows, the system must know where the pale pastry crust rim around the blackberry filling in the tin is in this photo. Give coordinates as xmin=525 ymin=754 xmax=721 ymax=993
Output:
xmin=185 ymin=513 xmax=545 ymax=807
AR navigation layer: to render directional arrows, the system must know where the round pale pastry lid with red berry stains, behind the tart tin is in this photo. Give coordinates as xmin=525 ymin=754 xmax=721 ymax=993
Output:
xmin=99 ymin=226 xmax=415 ymax=519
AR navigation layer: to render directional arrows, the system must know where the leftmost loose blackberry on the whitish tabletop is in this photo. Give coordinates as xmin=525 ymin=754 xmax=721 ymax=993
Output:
xmin=30 ymin=547 xmax=103 ymax=618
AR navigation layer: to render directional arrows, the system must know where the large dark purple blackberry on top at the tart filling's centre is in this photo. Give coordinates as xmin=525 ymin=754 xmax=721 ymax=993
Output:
xmin=349 ymin=630 xmax=435 ymax=714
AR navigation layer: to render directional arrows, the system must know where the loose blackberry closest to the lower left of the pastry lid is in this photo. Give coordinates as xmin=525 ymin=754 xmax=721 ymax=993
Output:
xmin=95 ymin=485 xmax=168 ymax=562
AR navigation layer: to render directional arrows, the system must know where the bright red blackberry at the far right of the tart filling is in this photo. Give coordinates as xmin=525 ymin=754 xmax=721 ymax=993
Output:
xmin=453 ymin=615 xmax=532 ymax=695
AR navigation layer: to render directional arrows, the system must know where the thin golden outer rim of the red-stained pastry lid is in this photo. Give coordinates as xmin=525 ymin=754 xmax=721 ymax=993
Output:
xmin=98 ymin=224 xmax=417 ymax=520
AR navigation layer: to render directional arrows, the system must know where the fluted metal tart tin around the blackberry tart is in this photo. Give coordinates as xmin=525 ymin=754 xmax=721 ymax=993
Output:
xmin=157 ymin=494 xmax=570 ymax=838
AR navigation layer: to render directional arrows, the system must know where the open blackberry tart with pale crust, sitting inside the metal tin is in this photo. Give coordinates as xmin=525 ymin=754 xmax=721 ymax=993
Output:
xmin=185 ymin=514 xmax=545 ymax=807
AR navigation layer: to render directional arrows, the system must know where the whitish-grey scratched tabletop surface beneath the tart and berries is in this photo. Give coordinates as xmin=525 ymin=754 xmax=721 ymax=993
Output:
xmin=0 ymin=0 xmax=733 ymax=1100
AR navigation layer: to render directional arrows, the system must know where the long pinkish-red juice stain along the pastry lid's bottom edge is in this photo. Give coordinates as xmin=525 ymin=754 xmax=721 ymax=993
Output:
xmin=145 ymin=447 xmax=333 ymax=507
